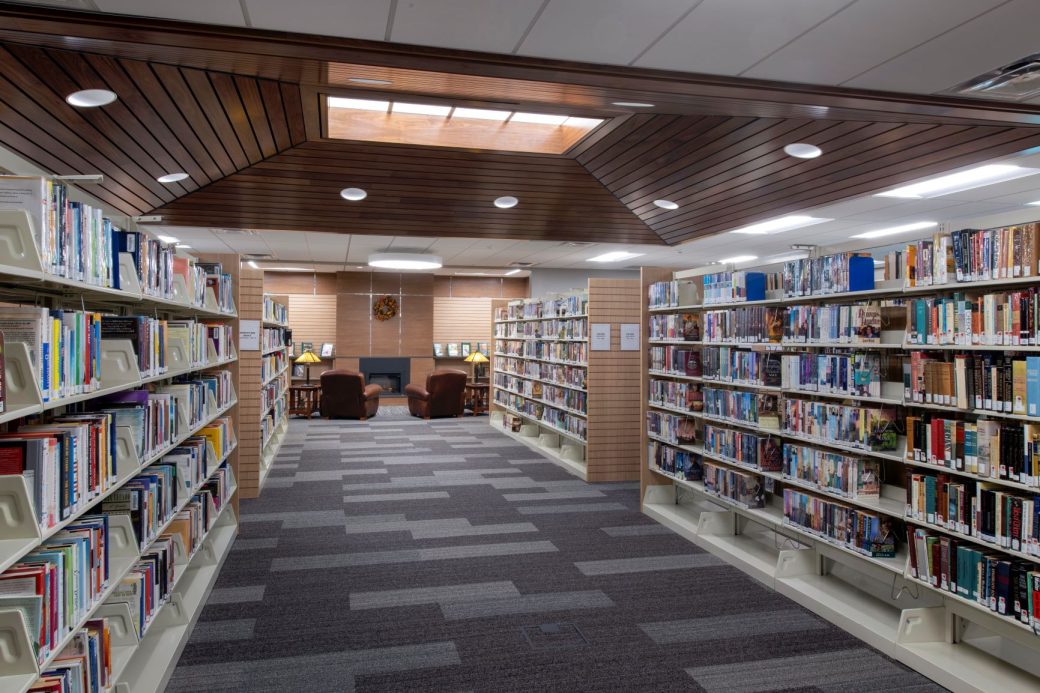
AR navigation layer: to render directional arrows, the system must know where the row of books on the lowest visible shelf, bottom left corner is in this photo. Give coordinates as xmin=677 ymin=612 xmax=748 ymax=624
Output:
xmin=28 ymin=618 xmax=114 ymax=693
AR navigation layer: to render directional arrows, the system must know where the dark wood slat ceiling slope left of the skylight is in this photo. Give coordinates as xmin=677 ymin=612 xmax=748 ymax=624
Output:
xmin=0 ymin=44 xmax=305 ymax=214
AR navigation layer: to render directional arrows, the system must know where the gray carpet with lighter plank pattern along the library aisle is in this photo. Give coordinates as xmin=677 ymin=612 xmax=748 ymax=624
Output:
xmin=167 ymin=410 xmax=942 ymax=693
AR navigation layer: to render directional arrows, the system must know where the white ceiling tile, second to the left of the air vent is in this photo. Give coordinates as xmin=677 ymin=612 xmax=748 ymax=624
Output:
xmin=744 ymin=0 xmax=1003 ymax=85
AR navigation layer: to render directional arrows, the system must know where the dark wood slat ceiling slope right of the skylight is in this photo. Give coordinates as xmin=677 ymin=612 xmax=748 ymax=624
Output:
xmin=577 ymin=114 xmax=1040 ymax=243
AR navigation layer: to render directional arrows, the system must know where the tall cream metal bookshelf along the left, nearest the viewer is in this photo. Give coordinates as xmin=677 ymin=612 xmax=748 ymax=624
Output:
xmin=0 ymin=198 xmax=238 ymax=692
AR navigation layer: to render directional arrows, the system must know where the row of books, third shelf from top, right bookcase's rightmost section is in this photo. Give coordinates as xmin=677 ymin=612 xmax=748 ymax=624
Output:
xmin=903 ymin=352 xmax=1040 ymax=416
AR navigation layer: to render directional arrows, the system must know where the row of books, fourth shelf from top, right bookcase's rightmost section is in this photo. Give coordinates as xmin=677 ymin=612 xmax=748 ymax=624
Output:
xmin=906 ymin=416 xmax=1040 ymax=486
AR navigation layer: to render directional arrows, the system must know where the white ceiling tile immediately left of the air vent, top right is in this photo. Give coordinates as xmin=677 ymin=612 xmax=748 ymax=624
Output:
xmin=844 ymin=0 xmax=1040 ymax=94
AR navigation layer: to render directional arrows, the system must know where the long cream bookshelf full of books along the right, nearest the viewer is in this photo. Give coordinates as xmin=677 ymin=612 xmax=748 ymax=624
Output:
xmin=641 ymin=225 xmax=1040 ymax=691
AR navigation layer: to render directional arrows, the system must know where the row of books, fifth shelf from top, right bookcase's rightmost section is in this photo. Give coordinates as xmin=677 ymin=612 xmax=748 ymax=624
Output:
xmin=906 ymin=470 xmax=1040 ymax=556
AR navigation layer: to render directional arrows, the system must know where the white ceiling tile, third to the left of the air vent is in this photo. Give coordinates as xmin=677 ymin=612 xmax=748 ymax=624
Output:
xmin=633 ymin=0 xmax=849 ymax=75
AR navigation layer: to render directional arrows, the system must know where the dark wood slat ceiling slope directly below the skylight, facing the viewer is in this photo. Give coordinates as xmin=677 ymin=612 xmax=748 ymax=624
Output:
xmin=148 ymin=142 xmax=660 ymax=243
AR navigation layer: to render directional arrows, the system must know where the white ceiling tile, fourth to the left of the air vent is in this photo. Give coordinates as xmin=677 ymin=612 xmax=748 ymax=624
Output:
xmin=518 ymin=0 xmax=696 ymax=65
